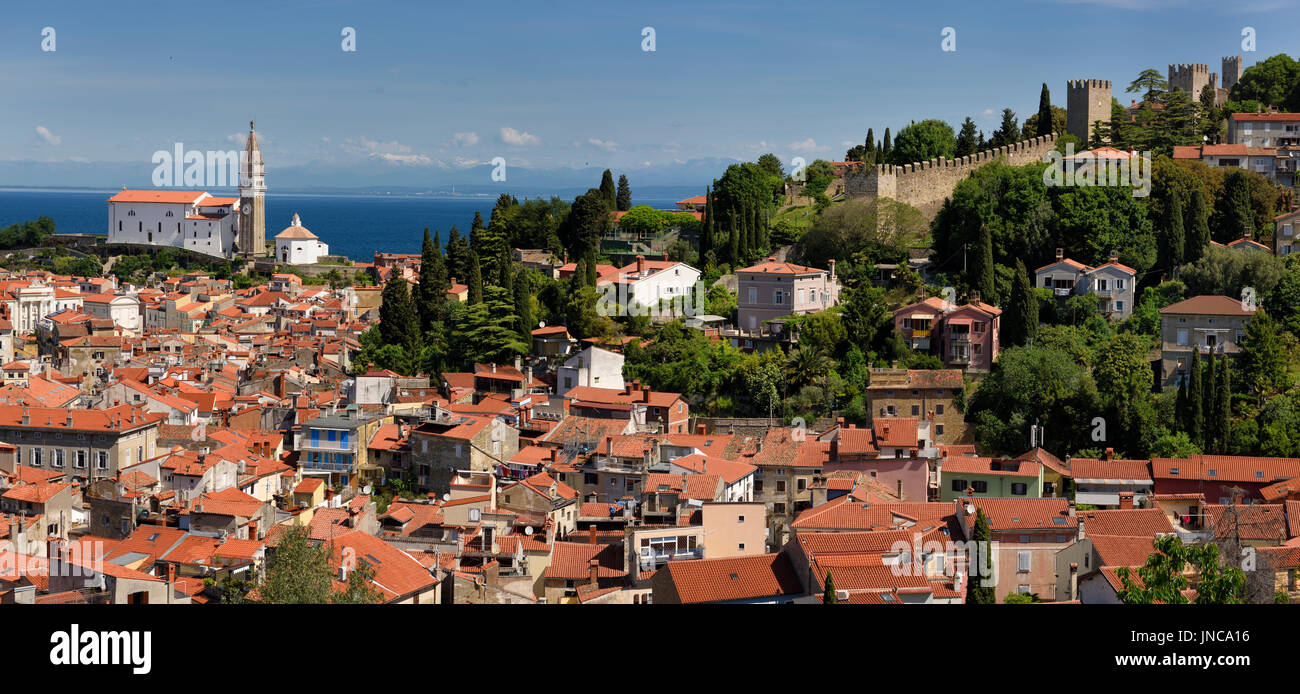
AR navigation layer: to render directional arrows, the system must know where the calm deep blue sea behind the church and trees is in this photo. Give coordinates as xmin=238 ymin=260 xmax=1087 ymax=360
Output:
xmin=0 ymin=188 xmax=675 ymax=261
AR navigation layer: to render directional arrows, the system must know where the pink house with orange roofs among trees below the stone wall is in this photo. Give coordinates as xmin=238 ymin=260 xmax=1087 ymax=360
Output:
xmin=894 ymin=292 xmax=1002 ymax=372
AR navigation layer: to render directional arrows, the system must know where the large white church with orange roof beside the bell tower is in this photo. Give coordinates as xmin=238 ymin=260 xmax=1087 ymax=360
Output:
xmin=108 ymin=190 xmax=239 ymax=257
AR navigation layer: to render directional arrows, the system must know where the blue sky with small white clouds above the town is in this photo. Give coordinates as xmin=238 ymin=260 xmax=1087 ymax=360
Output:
xmin=0 ymin=0 xmax=1300 ymax=185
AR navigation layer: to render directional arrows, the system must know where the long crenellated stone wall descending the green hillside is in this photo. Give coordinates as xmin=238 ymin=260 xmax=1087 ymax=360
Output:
xmin=844 ymin=134 xmax=1057 ymax=218
